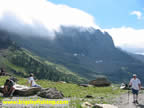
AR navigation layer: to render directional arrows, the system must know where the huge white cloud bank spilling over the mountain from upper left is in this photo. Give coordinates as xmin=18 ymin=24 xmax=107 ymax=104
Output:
xmin=0 ymin=0 xmax=99 ymax=36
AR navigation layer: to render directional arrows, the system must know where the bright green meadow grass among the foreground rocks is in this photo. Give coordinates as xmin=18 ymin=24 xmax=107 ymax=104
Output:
xmin=0 ymin=77 xmax=123 ymax=108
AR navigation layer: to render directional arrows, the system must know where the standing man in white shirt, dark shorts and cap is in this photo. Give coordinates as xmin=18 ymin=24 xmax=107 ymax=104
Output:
xmin=129 ymin=74 xmax=141 ymax=104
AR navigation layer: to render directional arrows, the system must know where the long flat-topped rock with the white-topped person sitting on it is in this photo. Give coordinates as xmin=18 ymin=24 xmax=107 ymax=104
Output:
xmin=0 ymin=84 xmax=41 ymax=96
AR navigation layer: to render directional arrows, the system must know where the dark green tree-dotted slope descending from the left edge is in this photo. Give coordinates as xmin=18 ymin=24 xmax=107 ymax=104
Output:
xmin=0 ymin=31 xmax=87 ymax=83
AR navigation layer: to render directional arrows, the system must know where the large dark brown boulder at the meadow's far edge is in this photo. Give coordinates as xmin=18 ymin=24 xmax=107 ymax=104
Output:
xmin=89 ymin=77 xmax=111 ymax=87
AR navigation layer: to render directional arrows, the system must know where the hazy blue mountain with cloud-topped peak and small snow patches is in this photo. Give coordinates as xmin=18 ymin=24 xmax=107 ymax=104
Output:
xmin=1 ymin=26 xmax=144 ymax=83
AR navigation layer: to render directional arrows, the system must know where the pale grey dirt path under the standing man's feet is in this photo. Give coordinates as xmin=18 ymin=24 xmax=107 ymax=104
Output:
xmin=114 ymin=91 xmax=144 ymax=108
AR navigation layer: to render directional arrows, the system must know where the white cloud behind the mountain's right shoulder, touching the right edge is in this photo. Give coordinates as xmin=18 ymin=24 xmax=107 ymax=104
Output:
xmin=105 ymin=27 xmax=144 ymax=48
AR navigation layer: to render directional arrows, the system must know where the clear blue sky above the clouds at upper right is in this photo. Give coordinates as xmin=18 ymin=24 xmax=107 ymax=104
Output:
xmin=48 ymin=0 xmax=144 ymax=29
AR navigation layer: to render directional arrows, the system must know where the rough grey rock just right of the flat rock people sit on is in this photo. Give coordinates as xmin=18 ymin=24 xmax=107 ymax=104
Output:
xmin=37 ymin=88 xmax=64 ymax=99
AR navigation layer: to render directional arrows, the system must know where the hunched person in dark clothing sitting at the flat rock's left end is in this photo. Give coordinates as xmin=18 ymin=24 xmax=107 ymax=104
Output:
xmin=3 ymin=78 xmax=17 ymax=97
